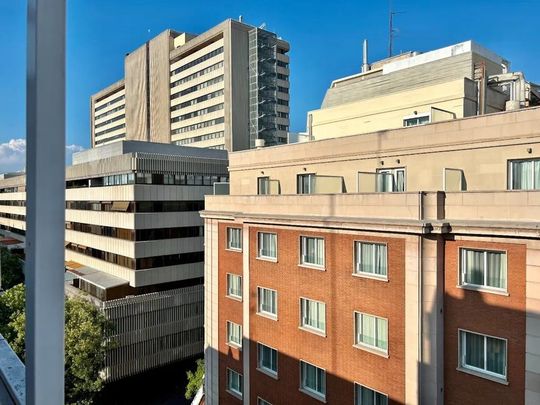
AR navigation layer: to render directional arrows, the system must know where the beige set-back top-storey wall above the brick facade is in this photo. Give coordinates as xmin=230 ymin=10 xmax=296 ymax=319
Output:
xmin=229 ymin=108 xmax=540 ymax=195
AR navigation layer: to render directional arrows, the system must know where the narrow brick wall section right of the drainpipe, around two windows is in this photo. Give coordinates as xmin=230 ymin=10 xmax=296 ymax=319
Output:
xmin=444 ymin=240 xmax=526 ymax=405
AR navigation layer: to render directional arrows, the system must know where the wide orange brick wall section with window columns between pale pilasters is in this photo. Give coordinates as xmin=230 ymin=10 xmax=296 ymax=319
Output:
xmin=250 ymin=227 xmax=405 ymax=404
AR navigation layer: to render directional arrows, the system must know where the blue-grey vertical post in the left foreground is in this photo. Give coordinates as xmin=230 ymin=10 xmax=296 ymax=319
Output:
xmin=26 ymin=0 xmax=66 ymax=405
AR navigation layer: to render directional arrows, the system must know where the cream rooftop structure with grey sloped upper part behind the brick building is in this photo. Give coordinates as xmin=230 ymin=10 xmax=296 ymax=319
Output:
xmin=307 ymin=41 xmax=540 ymax=139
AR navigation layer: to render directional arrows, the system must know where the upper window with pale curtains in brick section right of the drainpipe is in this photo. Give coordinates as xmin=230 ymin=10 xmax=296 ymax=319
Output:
xmin=460 ymin=249 xmax=507 ymax=291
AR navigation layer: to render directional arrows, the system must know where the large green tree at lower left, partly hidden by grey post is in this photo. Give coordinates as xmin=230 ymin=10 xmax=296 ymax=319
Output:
xmin=0 ymin=284 xmax=110 ymax=404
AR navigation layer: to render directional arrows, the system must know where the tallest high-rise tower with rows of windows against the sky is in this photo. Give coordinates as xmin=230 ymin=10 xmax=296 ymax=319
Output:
xmin=90 ymin=20 xmax=289 ymax=151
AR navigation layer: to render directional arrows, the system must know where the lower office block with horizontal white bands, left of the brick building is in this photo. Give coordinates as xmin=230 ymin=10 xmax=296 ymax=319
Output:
xmin=0 ymin=141 xmax=228 ymax=380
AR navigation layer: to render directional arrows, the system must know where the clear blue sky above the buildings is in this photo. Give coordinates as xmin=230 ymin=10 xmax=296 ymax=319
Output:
xmin=0 ymin=0 xmax=540 ymax=172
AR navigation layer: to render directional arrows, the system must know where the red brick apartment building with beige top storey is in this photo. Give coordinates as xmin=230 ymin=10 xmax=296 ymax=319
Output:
xmin=203 ymin=108 xmax=540 ymax=405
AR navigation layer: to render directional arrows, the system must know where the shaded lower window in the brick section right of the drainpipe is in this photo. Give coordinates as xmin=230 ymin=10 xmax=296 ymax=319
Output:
xmin=459 ymin=330 xmax=507 ymax=380
